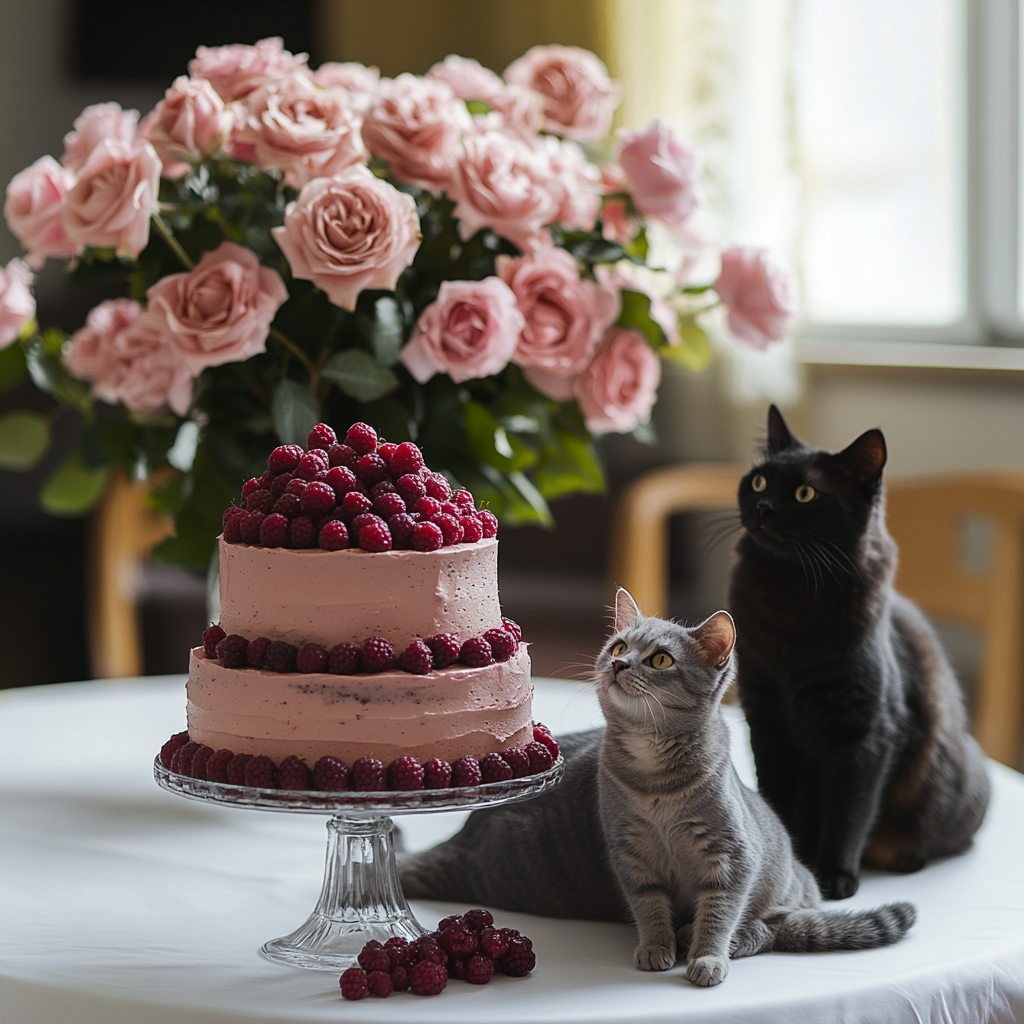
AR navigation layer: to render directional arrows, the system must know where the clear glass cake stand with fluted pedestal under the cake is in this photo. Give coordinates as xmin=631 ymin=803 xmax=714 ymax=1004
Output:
xmin=153 ymin=757 xmax=564 ymax=971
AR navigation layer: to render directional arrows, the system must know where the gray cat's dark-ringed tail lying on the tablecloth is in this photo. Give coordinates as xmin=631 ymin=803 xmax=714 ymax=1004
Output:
xmin=767 ymin=903 xmax=918 ymax=953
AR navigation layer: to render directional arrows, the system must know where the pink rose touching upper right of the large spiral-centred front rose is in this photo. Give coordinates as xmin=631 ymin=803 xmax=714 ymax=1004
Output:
xmin=362 ymin=74 xmax=470 ymax=194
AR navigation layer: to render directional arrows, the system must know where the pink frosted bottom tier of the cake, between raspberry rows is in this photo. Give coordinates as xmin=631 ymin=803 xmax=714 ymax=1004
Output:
xmin=187 ymin=644 xmax=534 ymax=767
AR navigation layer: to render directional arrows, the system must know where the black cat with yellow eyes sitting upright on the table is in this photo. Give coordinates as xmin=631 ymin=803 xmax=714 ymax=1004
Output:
xmin=730 ymin=406 xmax=989 ymax=899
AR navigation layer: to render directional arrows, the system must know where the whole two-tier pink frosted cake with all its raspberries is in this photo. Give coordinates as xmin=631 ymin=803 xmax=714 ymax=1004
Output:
xmin=162 ymin=424 xmax=557 ymax=790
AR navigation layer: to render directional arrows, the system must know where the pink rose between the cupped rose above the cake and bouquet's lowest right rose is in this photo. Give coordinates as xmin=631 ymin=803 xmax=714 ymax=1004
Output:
xmin=497 ymin=248 xmax=620 ymax=391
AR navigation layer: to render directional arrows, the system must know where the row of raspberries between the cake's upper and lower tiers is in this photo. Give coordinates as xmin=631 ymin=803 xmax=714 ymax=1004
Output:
xmin=203 ymin=618 xmax=522 ymax=676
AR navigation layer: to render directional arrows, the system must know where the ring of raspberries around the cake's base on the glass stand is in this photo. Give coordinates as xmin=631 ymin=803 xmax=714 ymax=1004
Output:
xmin=160 ymin=723 xmax=558 ymax=793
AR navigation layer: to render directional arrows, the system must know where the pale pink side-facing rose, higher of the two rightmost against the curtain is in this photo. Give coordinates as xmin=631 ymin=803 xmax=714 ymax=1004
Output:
xmin=617 ymin=118 xmax=700 ymax=226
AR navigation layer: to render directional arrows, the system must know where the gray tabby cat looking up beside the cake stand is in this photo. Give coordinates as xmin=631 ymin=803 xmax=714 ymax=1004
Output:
xmin=399 ymin=590 xmax=916 ymax=985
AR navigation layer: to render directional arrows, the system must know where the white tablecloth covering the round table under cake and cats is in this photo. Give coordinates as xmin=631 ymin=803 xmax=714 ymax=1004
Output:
xmin=0 ymin=677 xmax=1024 ymax=1024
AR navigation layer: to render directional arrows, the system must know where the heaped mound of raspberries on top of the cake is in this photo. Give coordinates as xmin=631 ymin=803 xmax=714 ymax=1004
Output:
xmin=223 ymin=423 xmax=498 ymax=551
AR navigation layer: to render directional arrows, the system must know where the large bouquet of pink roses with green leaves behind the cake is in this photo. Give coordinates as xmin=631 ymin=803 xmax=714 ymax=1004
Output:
xmin=0 ymin=39 xmax=795 ymax=568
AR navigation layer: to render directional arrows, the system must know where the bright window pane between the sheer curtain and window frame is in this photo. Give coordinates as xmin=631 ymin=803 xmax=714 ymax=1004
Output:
xmin=796 ymin=0 xmax=967 ymax=326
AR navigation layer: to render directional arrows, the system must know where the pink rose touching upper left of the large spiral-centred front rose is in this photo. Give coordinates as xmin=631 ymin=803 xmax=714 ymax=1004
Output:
xmin=234 ymin=74 xmax=366 ymax=188
